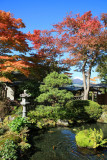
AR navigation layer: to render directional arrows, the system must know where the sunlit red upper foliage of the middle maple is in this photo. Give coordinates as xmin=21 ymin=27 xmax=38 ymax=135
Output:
xmin=27 ymin=30 xmax=61 ymax=58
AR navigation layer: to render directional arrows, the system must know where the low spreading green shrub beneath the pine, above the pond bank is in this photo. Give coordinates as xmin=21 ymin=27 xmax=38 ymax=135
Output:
xmin=28 ymin=105 xmax=66 ymax=128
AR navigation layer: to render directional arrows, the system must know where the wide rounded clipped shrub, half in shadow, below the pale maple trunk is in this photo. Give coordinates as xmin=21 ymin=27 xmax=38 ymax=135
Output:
xmin=65 ymin=100 xmax=102 ymax=121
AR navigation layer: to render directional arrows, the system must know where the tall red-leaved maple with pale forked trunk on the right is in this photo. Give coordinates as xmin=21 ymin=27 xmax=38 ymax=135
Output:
xmin=52 ymin=11 xmax=107 ymax=99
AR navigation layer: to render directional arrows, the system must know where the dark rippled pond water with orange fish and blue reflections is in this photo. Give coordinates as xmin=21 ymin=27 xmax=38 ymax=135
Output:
xmin=30 ymin=123 xmax=107 ymax=160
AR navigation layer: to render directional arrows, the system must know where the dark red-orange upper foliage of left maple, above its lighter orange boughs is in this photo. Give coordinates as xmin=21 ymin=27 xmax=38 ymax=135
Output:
xmin=0 ymin=10 xmax=29 ymax=54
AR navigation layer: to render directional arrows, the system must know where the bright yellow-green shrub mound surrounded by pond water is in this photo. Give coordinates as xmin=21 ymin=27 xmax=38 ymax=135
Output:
xmin=75 ymin=128 xmax=107 ymax=148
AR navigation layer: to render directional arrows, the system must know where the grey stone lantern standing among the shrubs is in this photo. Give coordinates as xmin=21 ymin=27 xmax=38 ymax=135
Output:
xmin=20 ymin=90 xmax=30 ymax=117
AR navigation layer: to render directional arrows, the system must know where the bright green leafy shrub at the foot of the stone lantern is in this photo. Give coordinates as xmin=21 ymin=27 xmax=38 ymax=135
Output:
xmin=9 ymin=117 xmax=28 ymax=133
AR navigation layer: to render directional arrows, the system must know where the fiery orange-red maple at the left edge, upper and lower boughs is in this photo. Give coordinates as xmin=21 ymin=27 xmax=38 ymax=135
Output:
xmin=0 ymin=10 xmax=30 ymax=81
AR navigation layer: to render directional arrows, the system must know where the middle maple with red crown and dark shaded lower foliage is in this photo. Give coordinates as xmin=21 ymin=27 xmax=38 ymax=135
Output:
xmin=28 ymin=30 xmax=66 ymax=80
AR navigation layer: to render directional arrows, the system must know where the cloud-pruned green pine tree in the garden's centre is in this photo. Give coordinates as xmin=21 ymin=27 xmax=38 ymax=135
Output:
xmin=36 ymin=72 xmax=73 ymax=107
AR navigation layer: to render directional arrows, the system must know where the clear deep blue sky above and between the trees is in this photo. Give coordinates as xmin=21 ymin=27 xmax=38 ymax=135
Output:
xmin=0 ymin=0 xmax=107 ymax=82
